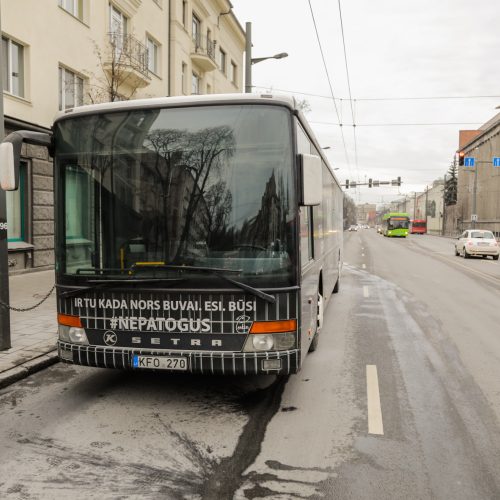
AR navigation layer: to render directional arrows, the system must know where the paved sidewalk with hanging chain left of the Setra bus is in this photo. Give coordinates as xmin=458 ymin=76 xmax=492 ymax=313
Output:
xmin=0 ymin=271 xmax=57 ymax=388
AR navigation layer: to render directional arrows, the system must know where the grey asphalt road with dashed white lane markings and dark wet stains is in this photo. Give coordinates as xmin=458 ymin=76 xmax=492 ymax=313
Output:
xmin=0 ymin=230 xmax=500 ymax=499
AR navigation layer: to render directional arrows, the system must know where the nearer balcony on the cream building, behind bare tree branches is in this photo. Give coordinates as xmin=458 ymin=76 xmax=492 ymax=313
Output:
xmin=103 ymin=32 xmax=151 ymax=88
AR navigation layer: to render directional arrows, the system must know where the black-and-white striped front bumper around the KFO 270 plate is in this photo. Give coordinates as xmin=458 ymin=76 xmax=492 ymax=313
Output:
xmin=57 ymin=341 xmax=300 ymax=375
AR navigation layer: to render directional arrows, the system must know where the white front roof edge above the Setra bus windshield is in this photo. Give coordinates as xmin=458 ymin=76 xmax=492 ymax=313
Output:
xmin=54 ymin=93 xmax=299 ymax=121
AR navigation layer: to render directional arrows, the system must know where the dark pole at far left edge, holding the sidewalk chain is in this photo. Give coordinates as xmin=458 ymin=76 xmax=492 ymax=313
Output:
xmin=0 ymin=1 xmax=11 ymax=351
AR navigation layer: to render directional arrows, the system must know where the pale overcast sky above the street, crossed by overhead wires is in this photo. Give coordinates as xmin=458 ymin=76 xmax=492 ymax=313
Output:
xmin=231 ymin=0 xmax=500 ymax=203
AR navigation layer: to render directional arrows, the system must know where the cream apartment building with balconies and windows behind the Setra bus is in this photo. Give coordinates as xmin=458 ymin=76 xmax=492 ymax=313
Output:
xmin=1 ymin=0 xmax=245 ymax=272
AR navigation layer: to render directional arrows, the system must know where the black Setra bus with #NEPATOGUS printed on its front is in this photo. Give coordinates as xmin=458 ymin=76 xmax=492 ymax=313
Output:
xmin=1 ymin=94 xmax=343 ymax=374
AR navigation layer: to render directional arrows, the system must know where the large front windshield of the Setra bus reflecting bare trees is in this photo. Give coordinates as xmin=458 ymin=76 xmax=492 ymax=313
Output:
xmin=55 ymin=104 xmax=297 ymax=286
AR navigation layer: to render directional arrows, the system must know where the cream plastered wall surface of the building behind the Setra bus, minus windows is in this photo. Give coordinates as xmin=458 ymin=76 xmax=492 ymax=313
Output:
xmin=1 ymin=0 xmax=245 ymax=271
